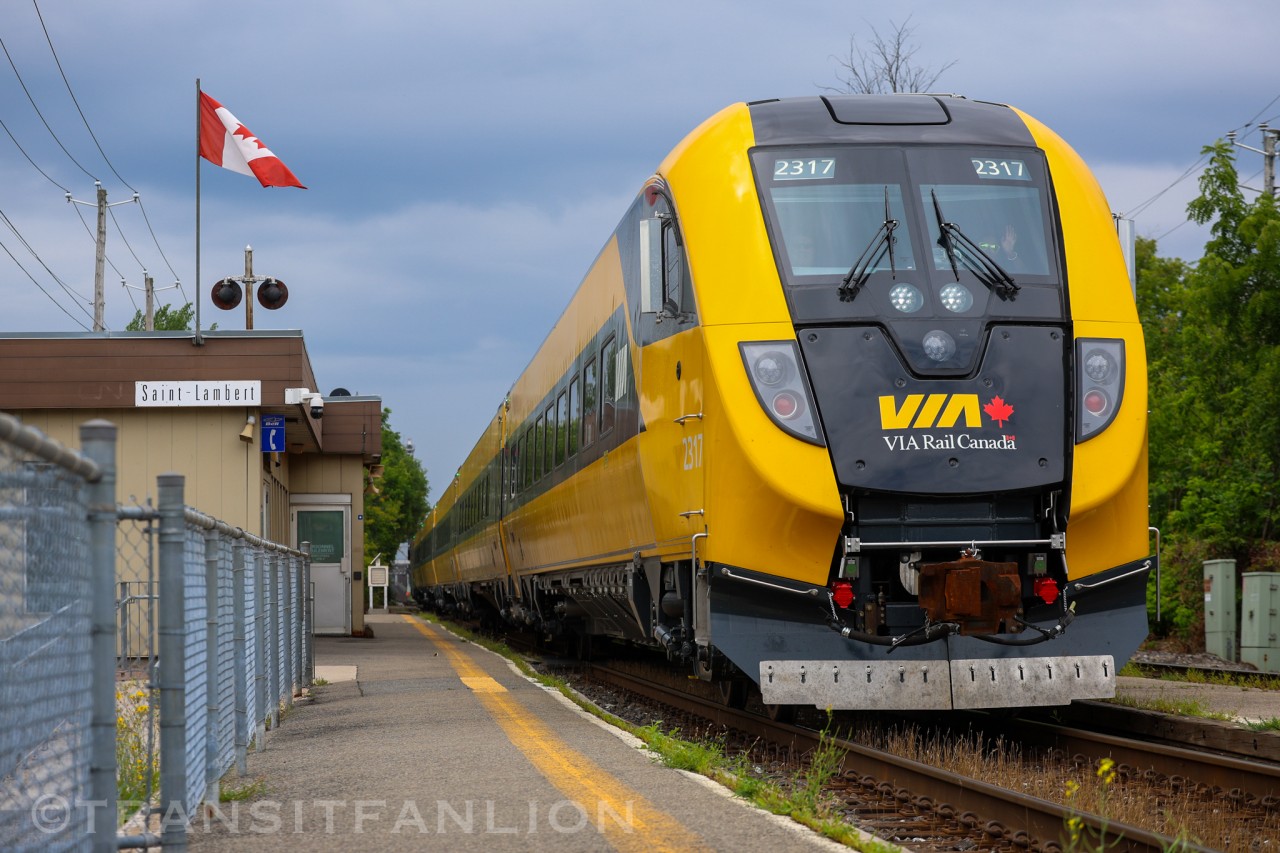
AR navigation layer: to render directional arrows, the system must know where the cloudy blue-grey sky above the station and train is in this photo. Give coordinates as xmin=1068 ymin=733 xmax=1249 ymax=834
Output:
xmin=0 ymin=0 xmax=1280 ymax=498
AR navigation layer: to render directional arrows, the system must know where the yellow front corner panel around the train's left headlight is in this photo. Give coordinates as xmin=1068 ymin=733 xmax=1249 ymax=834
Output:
xmin=662 ymin=104 xmax=842 ymax=585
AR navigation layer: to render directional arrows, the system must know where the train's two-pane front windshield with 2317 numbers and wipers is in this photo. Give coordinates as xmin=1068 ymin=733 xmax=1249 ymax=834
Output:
xmin=753 ymin=146 xmax=1060 ymax=302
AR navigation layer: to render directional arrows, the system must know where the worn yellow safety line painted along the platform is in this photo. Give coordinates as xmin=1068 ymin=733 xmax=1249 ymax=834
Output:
xmin=403 ymin=615 xmax=708 ymax=853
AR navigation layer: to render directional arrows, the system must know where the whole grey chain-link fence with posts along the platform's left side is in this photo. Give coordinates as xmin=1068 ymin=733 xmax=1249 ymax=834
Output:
xmin=0 ymin=414 xmax=312 ymax=853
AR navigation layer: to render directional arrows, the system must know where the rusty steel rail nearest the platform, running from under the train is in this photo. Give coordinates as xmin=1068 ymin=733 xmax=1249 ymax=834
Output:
xmin=590 ymin=663 xmax=1211 ymax=853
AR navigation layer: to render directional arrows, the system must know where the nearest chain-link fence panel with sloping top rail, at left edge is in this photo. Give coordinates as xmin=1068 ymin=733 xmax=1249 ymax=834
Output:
xmin=0 ymin=419 xmax=103 ymax=850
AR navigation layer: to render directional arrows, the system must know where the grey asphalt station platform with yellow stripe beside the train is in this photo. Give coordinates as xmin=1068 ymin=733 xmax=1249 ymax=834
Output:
xmin=188 ymin=615 xmax=847 ymax=853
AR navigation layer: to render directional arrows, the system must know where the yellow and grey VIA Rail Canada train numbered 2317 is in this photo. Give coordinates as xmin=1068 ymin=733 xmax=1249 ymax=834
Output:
xmin=411 ymin=95 xmax=1156 ymax=710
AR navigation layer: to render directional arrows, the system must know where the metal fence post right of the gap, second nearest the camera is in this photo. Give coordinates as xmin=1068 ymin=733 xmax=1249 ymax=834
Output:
xmin=156 ymin=474 xmax=188 ymax=853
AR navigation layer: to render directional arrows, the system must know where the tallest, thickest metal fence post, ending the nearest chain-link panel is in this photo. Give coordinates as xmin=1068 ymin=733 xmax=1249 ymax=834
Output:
xmin=79 ymin=420 xmax=118 ymax=853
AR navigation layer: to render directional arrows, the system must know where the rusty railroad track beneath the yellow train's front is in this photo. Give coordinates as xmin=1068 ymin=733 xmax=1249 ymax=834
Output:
xmin=578 ymin=665 xmax=1280 ymax=852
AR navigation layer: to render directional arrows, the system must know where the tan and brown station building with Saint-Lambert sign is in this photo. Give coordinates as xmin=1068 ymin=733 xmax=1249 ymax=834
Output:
xmin=0 ymin=329 xmax=381 ymax=635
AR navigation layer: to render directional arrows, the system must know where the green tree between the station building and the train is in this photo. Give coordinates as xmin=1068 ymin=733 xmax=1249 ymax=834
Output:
xmin=365 ymin=409 xmax=430 ymax=565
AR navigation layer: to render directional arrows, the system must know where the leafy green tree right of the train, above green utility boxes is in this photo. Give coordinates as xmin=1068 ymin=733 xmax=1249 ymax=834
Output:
xmin=1138 ymin=141 xmax=1280 ymax=639
